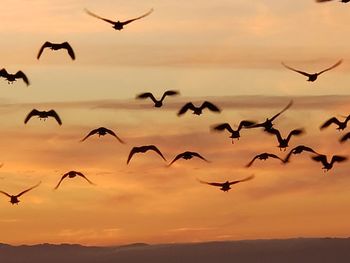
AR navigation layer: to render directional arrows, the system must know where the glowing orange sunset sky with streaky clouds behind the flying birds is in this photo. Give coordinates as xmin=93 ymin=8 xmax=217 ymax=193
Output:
xmin=0 ymin=0 xmax=350 ymax=248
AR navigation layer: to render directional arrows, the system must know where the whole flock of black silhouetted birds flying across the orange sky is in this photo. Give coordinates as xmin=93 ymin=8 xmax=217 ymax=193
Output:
xmin=0 ymin=3 xmax=350 ymax=204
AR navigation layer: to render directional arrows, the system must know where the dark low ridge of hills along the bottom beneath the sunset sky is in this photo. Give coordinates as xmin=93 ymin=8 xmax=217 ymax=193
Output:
xmin=0 ymin=238 xmax=350 ymax=263
